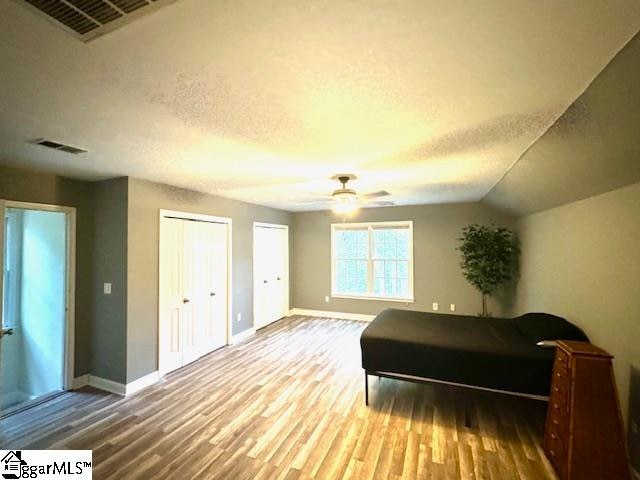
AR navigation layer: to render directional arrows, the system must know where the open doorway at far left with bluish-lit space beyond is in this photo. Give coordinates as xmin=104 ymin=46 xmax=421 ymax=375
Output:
xmin=0 ymin=200 xmax=75 ymax=416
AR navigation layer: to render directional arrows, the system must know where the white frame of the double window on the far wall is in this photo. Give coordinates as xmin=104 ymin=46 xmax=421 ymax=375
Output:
xmin=331 ymin=220 xmax=415 ymax=303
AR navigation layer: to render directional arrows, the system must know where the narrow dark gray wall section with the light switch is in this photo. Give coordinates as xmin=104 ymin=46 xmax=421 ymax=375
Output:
xmin=91 ymin=178 xmax=128 ymax=383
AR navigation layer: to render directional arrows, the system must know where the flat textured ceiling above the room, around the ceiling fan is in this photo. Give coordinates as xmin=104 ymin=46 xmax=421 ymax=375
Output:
xmin=0 ymin=0 xmax=640 ymax=210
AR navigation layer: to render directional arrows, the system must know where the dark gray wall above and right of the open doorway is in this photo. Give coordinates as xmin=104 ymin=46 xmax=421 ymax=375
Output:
xmin=0 ymin=165 xmax=94 ymax=376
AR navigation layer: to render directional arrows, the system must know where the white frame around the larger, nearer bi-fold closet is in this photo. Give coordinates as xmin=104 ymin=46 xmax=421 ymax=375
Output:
xmin=156 ymin=209 xmax=233 ymax=375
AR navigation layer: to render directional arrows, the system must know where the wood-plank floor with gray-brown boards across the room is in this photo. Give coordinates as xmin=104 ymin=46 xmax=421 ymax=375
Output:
xmin=0 ymin=316 xmax=555 ymax=480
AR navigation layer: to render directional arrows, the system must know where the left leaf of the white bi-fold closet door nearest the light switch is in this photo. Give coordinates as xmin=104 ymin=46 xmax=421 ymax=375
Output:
xmin=158 ymin=218 xmax=185 ymax=373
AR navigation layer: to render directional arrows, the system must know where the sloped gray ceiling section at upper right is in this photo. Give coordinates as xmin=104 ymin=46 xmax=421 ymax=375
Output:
xmin=485 ymin=34 xmax=640 ymax=215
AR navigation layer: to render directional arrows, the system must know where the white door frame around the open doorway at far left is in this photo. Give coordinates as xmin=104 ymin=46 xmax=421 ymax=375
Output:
xmin=0 ymin=200 xmax=76 ymax=390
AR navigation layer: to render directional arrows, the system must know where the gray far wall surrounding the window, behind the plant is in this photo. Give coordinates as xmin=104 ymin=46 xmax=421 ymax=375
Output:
xmin=291 ymin=203 xmax=512 ymax=316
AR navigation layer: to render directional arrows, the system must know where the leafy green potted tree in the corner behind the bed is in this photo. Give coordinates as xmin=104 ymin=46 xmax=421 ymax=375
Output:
xmin=458 ymin=224 xmax=519 ymax=317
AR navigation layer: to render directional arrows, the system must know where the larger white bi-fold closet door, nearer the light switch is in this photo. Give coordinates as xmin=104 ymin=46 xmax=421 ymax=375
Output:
xmin=159 ymin=216 xmax=230 ymax=374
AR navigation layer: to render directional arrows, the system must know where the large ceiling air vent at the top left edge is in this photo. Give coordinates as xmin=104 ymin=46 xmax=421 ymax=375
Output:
xmin=19 ymin=0 xmax=175 ymax=41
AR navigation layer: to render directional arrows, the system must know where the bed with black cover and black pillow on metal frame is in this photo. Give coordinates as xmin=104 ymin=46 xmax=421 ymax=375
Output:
xmin=360 ymin=309 xmax=588 ymax=404
